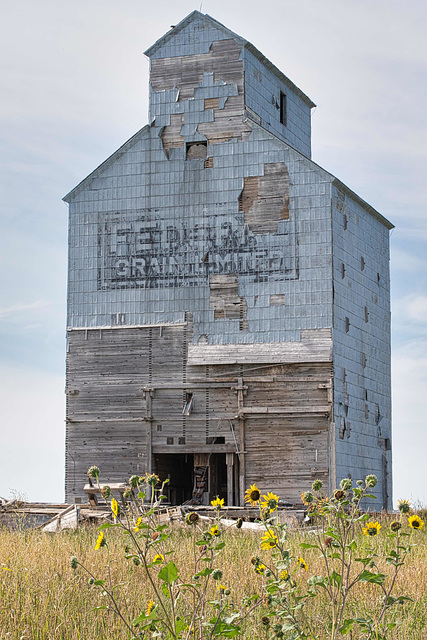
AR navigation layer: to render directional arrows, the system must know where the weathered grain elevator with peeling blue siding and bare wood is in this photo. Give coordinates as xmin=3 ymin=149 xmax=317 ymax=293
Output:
xmin=64 ymin=11 xmax=392 ymax=507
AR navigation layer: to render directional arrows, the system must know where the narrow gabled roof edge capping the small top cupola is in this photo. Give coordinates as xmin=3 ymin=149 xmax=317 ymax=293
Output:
xmin=144 ymin=11 xmax=316 ymax=108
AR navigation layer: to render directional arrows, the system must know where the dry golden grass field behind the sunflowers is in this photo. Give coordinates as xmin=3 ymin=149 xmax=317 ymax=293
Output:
xmin=0 ymin=514 xmax=427 ymax=640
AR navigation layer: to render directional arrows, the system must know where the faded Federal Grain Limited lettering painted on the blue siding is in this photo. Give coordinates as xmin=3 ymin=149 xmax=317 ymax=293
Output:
xmin=98 ymin=205 xmax=298 ymax=289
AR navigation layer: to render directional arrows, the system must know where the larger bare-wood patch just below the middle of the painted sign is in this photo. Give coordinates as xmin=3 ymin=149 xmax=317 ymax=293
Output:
xmin=209 ymin=273 xmax=248 ymax=331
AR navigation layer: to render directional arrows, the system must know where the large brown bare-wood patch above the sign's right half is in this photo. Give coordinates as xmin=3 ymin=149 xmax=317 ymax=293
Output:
xmin=239 ymin=162 xmax=289 ymax=233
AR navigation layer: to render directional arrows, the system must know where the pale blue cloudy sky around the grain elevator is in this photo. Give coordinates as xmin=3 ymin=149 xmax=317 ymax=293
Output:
xmin=0 ymin=0 xmax=427 ymax=504
